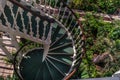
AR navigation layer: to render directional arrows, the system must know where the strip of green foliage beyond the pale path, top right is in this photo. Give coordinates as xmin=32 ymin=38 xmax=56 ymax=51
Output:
xmin=71 ymin=0 xmax=120 ymax=13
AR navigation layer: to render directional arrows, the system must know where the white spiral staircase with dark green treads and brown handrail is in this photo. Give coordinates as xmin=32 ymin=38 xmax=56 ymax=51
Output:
xmin=0 ymin=0 xmax=85 ymax=80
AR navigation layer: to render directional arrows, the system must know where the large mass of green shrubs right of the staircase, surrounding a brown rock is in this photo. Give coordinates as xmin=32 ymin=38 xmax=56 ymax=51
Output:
xmin=76 ymin=13 xmax=120 ymax=78
